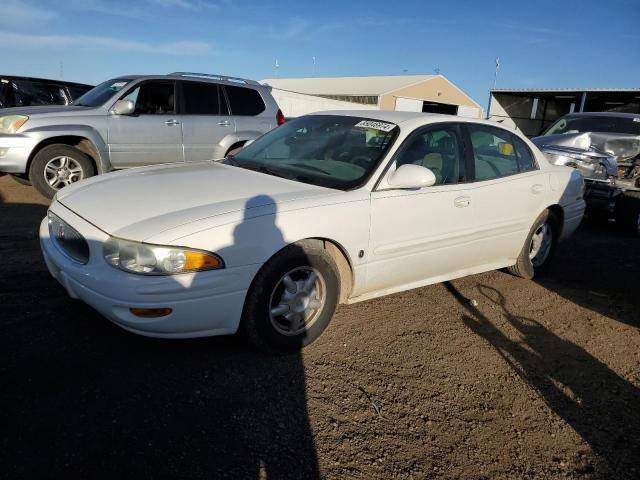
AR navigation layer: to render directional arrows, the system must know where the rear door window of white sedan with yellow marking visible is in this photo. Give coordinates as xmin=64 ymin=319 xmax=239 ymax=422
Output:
xmin=468 ymin=124 xmax=519 ymax=181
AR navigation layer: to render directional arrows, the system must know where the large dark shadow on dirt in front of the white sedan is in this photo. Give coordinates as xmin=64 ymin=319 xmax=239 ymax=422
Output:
xmin=0 ymin=193 xmax=319 ymax=479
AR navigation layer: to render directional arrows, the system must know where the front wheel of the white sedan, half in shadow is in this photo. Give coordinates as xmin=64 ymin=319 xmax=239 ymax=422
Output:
xmin=240 ymin=240 xmax=340 ymax=353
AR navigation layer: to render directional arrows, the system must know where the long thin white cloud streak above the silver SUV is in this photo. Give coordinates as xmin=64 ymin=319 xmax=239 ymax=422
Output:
xmin=0 ymin=31 xmax=214 ymax=55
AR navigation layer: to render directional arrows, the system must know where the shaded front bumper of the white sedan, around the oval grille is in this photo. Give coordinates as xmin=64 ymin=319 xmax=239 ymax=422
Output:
xmin=40 ymin=203 xmax=259 ymax=338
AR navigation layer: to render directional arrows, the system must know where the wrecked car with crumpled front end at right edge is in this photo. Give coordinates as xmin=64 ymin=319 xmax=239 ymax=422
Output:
xmin=532 ymin=112 xmax=640 ymax=235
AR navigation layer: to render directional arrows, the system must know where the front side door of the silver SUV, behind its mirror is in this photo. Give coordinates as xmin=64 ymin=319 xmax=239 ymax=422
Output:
xmin=109 ymin=80 xmax=183 ymax=168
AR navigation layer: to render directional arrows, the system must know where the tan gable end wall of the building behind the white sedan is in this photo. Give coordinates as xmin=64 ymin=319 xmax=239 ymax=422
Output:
xmin=380 ymin=77 xmax=482 ymax=110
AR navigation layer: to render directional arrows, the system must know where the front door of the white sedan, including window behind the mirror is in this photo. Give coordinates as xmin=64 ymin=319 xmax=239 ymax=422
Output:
xmin=366 ymin=124 xmax=475 ymax=291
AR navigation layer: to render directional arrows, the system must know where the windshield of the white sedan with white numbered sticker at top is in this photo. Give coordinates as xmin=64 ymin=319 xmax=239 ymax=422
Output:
xmin=226 ymin=115 xmax=399 ymax=190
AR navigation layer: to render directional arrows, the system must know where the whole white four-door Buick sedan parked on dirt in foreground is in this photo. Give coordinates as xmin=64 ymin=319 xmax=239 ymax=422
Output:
xmin=40 ymin=111 xmax=585 ymax=351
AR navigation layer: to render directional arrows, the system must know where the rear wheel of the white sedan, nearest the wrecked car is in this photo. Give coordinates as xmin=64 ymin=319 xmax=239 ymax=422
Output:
xmin=508 ymin=210 xmax=560 ymax=280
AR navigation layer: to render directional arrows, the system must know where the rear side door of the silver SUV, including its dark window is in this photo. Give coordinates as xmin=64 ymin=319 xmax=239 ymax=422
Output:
xmin=178 ymin=81 xmax=235 ymax=162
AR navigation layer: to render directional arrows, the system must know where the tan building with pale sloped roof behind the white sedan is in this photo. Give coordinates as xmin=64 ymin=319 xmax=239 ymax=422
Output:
xmin=261 ymin=75 xmax=482 ymax=118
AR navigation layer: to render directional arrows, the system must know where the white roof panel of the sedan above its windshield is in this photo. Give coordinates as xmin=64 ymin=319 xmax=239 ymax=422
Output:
xmin=312 ymin=110 xmax=514 ymax=131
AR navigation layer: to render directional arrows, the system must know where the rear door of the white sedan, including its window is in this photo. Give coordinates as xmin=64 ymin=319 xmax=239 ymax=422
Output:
xmin=467 ymin=123 xmax=549 ymax=265
